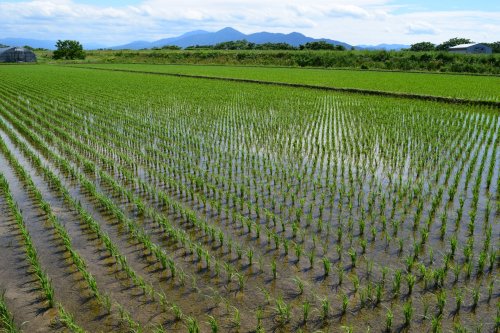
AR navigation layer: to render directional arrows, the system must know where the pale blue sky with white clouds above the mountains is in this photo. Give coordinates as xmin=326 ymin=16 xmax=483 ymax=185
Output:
xmin=0 ymin=0 xmax=500 ymax=46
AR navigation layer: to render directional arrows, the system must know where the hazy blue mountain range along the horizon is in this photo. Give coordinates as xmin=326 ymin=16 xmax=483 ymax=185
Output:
xmin=0 ymin=28 xmax=409 ymax=50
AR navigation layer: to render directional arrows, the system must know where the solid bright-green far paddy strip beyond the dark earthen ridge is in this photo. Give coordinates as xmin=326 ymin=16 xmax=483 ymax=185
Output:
xmin=69 ymin=64 xmax=500 ymax=101
